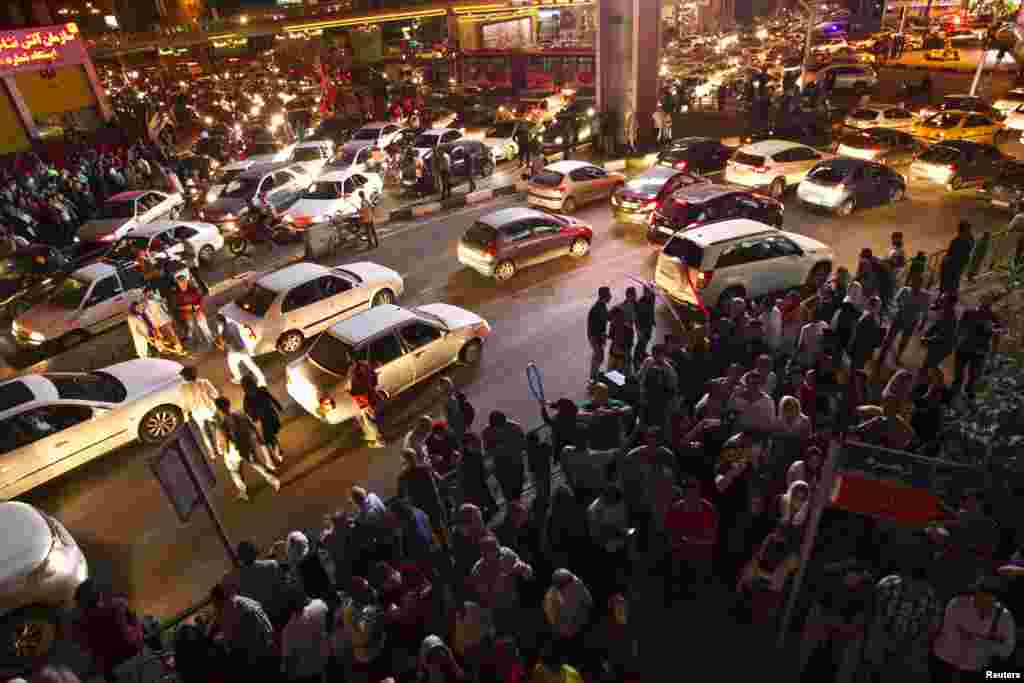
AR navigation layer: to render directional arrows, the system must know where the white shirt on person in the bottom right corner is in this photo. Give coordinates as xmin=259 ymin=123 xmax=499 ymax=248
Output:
xmin=933 ymin=595 xmax=1017 ymax=671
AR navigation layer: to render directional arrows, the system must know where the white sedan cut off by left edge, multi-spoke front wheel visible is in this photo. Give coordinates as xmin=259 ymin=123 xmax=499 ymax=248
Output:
xmin=0 ymin=358 xmax=182 ymax=501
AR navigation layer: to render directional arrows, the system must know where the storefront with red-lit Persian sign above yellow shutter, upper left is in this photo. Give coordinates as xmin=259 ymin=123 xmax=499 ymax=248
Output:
xmin=0 ymin=24 xmax=111 ymax=155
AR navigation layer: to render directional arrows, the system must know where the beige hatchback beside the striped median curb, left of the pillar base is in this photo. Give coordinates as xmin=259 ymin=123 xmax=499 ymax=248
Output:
xmin=526 ymin=161 xmax=626 ymax=213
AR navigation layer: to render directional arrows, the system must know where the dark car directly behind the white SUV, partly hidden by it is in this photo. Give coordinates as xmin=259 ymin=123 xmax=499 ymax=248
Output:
xmin=647 ymin=183 xmax=785 ymax=244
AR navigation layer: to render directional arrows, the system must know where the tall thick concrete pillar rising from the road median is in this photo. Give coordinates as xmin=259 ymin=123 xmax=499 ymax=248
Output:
xmin=597 ymin=0 xmax=662 ymax=150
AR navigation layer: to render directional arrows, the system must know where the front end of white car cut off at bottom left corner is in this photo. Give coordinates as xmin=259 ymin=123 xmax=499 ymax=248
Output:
xmin=0 ymin=501 xmax=89 ymax=676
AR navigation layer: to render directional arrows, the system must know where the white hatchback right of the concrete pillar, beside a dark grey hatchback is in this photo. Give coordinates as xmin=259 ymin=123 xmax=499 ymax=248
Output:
xmin=725 ymin=140 xmax=835 ymax=199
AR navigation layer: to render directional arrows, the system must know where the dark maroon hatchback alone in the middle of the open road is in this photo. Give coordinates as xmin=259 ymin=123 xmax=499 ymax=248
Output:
xmin=459 ymin=207 xmax=594 ymax=281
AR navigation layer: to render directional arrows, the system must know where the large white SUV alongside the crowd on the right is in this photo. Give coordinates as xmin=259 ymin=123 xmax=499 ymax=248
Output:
xmin=654 ymin=218 xmax=835 ymax=310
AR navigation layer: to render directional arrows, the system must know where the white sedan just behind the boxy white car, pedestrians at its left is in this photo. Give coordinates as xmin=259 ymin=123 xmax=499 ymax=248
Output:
xmin=220 ymin=262 xmax=406 ymax=354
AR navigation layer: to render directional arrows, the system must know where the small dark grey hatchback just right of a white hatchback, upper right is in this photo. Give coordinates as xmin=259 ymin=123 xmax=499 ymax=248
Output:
xmin=797 ymin=159 xmax=906 ymax=216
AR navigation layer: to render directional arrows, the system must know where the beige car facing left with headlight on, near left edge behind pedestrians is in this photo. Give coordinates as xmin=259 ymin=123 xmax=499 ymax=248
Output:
xmin=11 ymin=261 xmax=145 ymax=349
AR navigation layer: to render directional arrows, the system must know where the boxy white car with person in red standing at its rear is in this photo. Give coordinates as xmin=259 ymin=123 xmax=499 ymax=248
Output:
xmin=286 ymin=303 xmax=490 ymax=424
